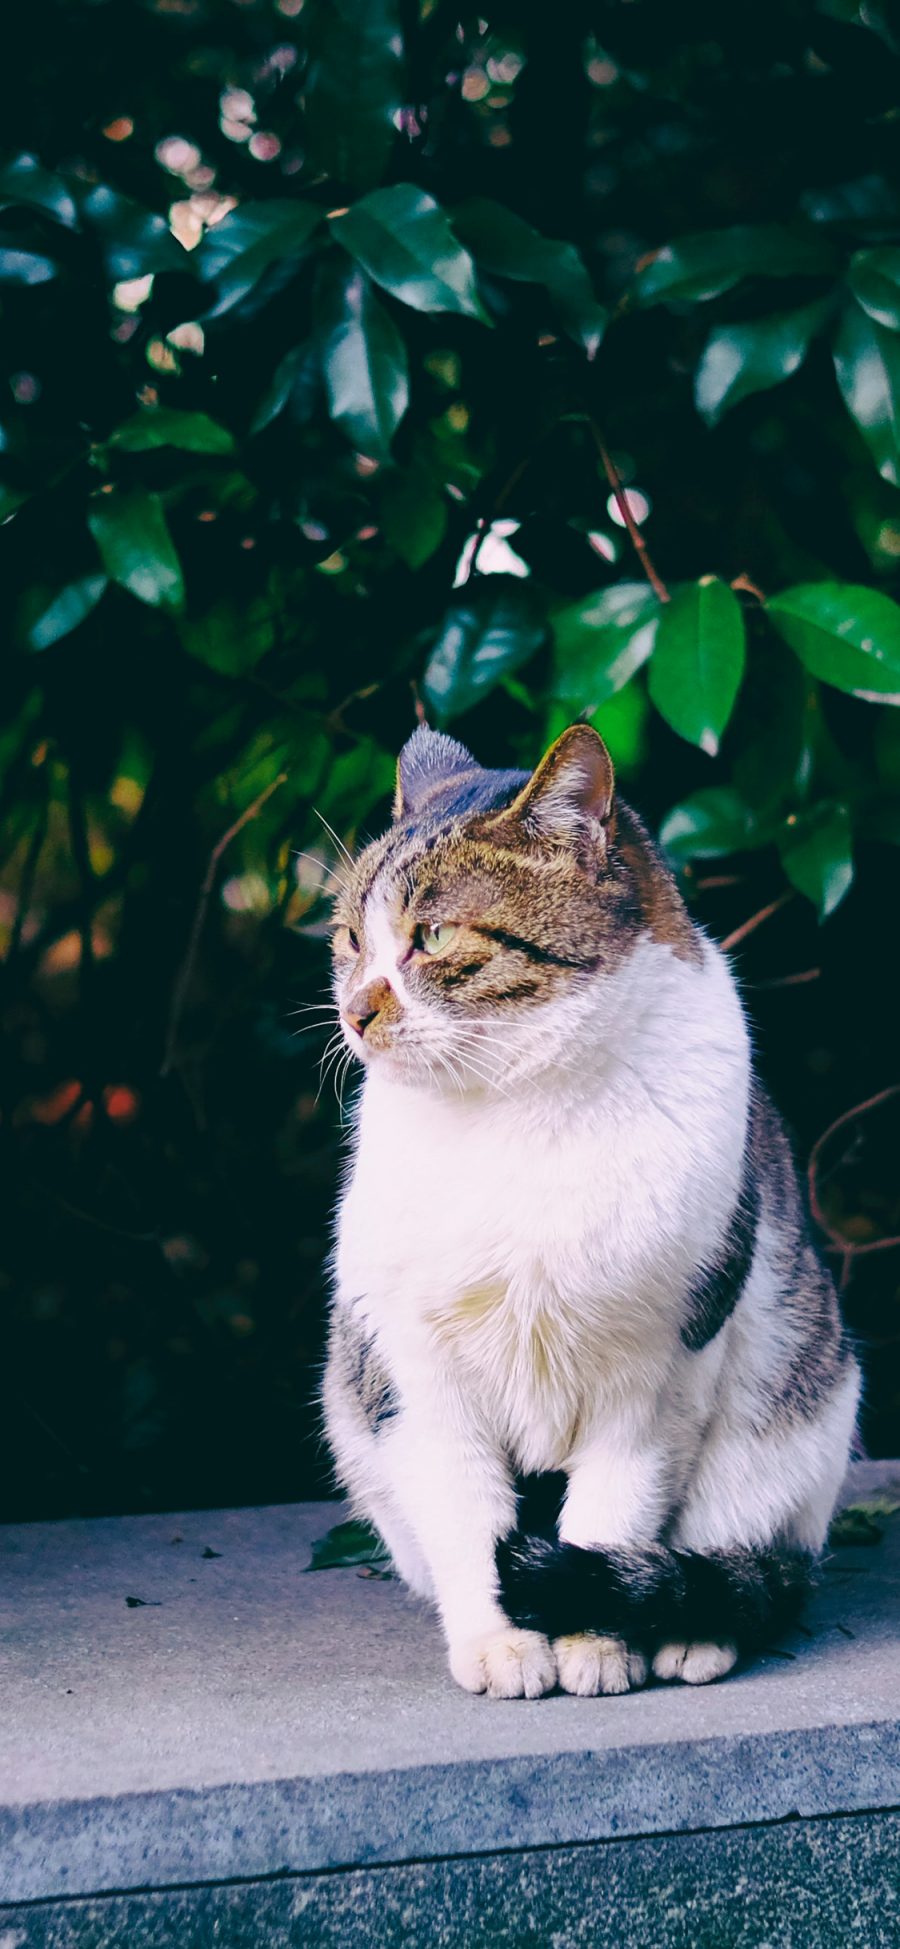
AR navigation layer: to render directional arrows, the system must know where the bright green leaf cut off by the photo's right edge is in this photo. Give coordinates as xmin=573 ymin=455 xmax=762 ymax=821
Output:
xmin=766 ymin=583 xmax=900 ymax=704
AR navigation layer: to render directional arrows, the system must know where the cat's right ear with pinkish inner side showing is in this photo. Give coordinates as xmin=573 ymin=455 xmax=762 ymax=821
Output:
xmin=501 ymin=725 xmax=616 ymax=846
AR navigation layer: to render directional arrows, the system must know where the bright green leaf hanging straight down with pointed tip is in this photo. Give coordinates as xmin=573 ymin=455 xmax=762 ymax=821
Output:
xmin=651 ymin=575 xmax=744 ymax=756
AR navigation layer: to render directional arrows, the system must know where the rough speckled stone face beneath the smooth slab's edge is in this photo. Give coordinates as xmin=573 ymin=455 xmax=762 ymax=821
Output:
xmin=0 ymin=1815 xmax=900 ymax=1949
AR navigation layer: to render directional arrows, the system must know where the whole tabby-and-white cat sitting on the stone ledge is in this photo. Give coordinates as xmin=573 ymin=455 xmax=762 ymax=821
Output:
xmin=323 ymin=723 xmax=859 ymax=1698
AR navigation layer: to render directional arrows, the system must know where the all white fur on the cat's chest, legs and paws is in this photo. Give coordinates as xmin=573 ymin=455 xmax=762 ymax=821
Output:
xmin=325 ymin=919 xmax=855 ymax=1696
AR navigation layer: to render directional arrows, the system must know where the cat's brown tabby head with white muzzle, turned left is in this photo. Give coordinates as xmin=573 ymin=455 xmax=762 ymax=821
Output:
xmin=333 ymin=725 xmax=692 ymax=1089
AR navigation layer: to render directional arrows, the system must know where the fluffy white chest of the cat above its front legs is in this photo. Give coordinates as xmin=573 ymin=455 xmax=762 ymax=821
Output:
xmin=337 ymin=957 xmax=746 ymax=1468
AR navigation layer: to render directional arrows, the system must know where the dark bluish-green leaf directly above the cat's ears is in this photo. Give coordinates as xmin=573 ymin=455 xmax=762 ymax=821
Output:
xmin=423 ymin=575 xmax=547 ymax=723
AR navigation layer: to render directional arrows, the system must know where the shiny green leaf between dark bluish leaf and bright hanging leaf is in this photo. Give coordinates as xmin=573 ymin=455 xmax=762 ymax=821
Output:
xmin=551 ymin=583 xmax=660 ymax=711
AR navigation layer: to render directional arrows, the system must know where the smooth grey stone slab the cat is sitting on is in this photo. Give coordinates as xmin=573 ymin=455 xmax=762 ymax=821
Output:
xmin=0 ymin=1464 xmax=900 ymax=1902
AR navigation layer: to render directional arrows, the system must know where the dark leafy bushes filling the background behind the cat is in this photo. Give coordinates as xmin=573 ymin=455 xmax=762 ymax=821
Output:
xmin=0 ymin=0 xmax=900 ymax=1516
